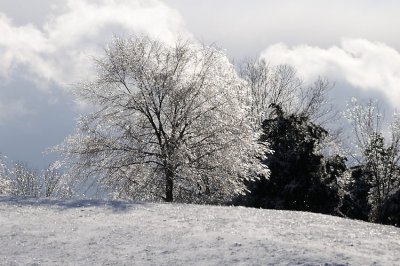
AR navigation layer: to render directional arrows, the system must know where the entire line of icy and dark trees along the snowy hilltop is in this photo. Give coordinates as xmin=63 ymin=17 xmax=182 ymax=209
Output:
xmin=0 ymin=36 xmax=400 ymax=226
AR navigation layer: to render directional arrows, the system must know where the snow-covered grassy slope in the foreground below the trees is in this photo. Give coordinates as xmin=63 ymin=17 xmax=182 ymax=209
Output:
xmin=0 ymin=197 xmax=400 ymax=265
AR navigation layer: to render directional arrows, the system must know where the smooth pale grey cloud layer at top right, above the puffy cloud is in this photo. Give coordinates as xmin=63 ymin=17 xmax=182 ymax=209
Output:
xmin=169 ymin=0 xmax=400 ymax=59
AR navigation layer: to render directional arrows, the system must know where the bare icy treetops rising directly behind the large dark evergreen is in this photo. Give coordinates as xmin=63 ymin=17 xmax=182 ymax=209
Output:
xmin=241 ymin=59 xmax=337 ymax=125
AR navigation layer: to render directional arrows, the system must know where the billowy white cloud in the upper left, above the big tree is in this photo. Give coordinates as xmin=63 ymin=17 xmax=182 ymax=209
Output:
xmin=0 ymin=0 xmax=191 ymax=88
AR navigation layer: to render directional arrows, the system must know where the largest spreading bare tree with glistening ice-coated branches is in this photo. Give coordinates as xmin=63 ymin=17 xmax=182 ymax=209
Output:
xmin=56 ymin=36 xmax=268 ymax=202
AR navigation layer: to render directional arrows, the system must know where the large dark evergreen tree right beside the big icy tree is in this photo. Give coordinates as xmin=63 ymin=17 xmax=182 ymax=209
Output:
xmin=242 ymin=105 xmax=346 ymax=214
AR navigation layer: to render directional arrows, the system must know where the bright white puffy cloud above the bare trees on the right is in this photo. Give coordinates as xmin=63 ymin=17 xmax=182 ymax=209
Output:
xmin=261 ymin=38 xmax=400 ymax=107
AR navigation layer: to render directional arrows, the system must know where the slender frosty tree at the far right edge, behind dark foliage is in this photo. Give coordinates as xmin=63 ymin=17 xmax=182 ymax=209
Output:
xmin=346 ymin=99 xmax=400 ymax=221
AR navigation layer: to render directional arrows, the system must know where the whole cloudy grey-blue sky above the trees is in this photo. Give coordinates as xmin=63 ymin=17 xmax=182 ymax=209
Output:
xmin=0 ymin=0 xmax=400 ymax=168
